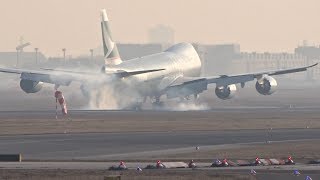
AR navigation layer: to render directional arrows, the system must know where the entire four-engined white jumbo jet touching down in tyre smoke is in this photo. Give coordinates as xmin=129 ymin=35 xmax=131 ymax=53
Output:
xmin=0 ymin=10 xmax=317 ymax=108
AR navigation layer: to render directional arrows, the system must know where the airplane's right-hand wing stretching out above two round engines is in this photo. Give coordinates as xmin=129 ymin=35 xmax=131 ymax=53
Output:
xmin=163 ymin=63 xmax=318 ymax=98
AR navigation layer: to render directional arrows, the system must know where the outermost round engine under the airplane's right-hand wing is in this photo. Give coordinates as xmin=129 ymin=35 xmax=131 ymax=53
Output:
xmin=256 ymin=76 xmax=278 ymax=95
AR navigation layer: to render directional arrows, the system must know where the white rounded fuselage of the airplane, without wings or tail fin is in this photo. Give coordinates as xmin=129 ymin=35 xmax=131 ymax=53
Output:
xmin=106 ymin=43 xmax=201 ymax=96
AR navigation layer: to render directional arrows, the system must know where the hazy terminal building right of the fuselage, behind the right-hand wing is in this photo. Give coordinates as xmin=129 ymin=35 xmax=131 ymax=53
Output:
xmin=195 ymin=44 xmax=320 ymax=80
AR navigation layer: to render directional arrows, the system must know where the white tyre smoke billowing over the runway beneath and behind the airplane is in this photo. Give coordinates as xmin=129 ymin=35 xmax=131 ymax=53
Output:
xmin=43 ymin=64 xmax=209 ymax=111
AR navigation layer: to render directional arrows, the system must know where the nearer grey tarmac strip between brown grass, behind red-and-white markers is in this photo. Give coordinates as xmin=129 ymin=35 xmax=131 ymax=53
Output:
xmin=0 ymin=129 xmax=320 ymax=161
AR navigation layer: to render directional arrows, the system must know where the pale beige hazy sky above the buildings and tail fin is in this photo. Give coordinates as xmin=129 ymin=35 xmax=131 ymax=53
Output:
xmin=0 ymin=0 xmax=320 ymax=56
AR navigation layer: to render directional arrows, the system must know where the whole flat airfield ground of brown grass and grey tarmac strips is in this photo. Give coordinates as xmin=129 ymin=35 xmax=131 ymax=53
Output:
xmin=0 ymin=91 xmax=320 ymax=179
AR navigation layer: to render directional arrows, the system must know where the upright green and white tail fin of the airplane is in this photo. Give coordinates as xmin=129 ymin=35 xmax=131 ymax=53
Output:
xmin=101 ymin=9 xmax=122 ymax=65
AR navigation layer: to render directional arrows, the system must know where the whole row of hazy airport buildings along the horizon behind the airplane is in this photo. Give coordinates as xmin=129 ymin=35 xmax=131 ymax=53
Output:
xmin=0 ymin=43 xmax=320 ymax=81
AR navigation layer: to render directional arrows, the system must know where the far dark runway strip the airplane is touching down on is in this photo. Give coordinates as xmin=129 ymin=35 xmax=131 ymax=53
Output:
xmin=0 ymin=104 xmax=320 ymax=121
